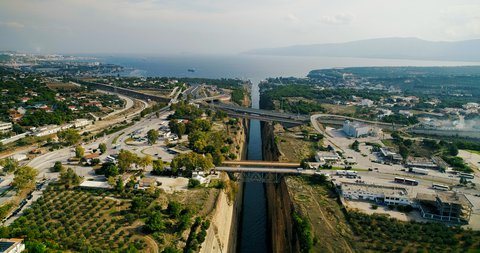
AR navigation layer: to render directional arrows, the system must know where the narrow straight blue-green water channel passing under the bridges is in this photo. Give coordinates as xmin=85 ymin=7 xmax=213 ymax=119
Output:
xmin=239 ymin=83 xmax=268 ymax=253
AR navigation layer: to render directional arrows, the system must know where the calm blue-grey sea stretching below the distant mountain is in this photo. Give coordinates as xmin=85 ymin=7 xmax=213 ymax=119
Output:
xmin=96 ymin=54 xmax=480 ymax=82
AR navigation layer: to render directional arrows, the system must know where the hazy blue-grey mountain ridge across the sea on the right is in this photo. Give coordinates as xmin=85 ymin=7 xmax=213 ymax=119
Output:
xmin=244 ymin=38 xmax=480 ymax=61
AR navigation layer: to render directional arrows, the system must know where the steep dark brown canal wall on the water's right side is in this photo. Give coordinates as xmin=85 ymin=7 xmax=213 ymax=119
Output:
xmin=261 ymin=123 xmax=300 ymax=253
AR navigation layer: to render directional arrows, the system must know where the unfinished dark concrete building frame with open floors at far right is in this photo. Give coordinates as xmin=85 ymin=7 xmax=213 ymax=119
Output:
xmin=416 ymin=192 xmax=473 ymax=223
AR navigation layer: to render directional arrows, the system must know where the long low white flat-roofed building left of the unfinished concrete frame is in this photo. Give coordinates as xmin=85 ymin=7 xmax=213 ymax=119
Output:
xmin=341 ymin=183 xmax=412 ymax=205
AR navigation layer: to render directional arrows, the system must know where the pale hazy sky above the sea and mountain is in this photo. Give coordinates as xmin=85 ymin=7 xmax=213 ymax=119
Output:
xmin=0 ymin=0 xmax=480 ymax=54
